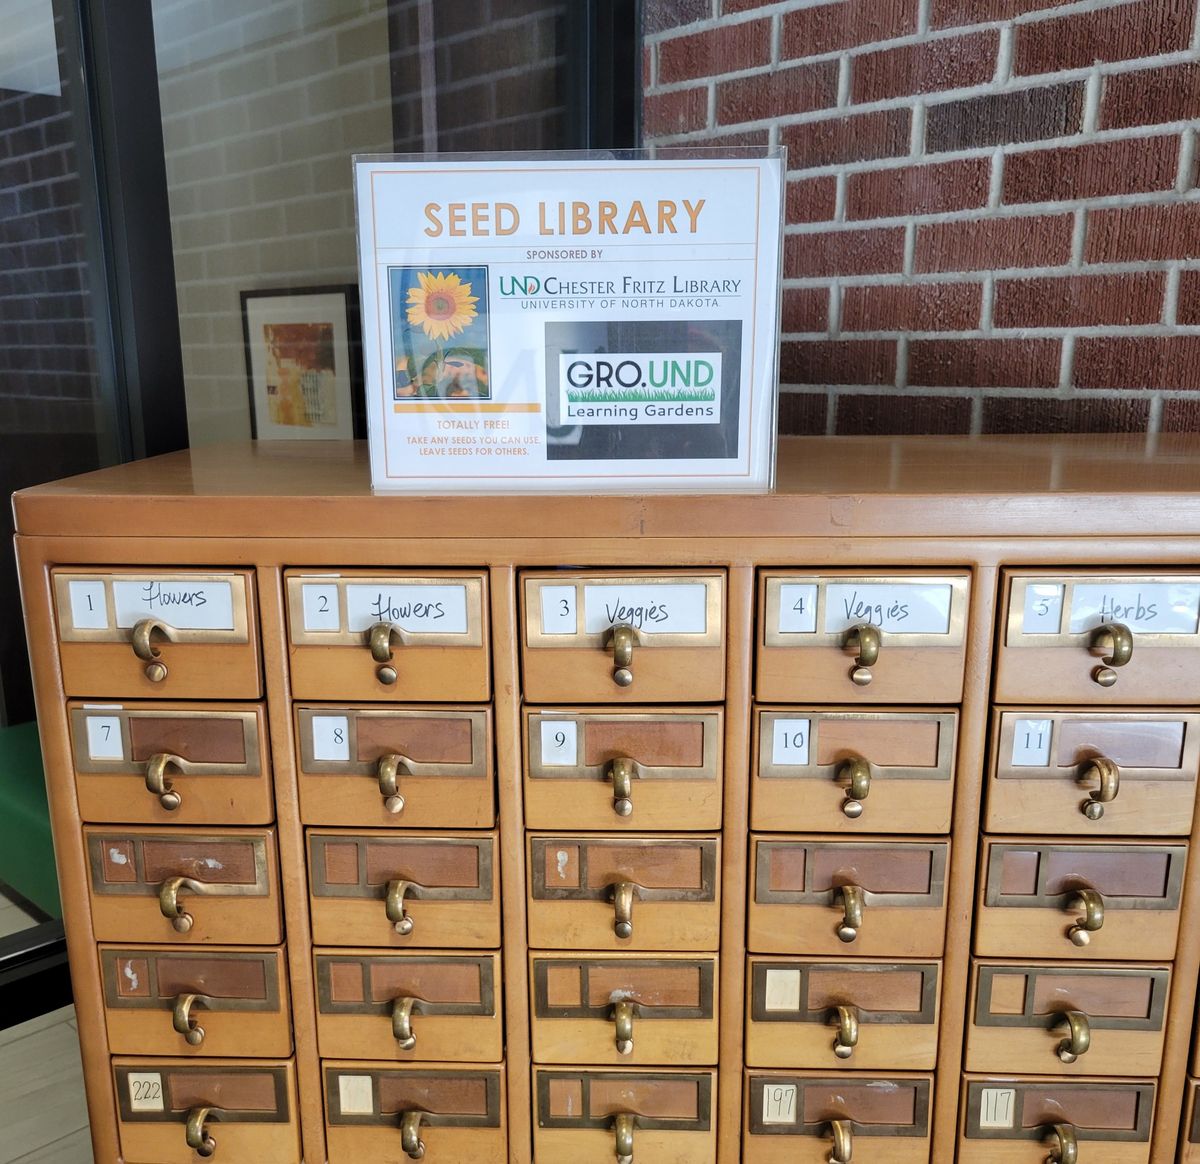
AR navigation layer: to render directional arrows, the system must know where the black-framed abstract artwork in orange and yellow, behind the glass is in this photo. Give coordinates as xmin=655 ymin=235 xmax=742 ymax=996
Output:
xmin=241 ymin=284 xmax=366 ymax=440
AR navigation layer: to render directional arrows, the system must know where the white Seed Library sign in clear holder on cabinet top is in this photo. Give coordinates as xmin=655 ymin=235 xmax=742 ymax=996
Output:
xmin=355 ymin=151 xmax=782 ymax=492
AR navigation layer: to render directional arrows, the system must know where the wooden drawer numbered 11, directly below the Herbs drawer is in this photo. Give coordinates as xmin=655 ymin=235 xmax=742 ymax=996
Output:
xmin=986 ymin=708 xmax=1200 ymax=836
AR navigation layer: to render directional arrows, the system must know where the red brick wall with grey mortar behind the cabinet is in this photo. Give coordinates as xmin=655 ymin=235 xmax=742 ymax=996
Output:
xmin=643 ymin=0 xmax=1200 ymax=433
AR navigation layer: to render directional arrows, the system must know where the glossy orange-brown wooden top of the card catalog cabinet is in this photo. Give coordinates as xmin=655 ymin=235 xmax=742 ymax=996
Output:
xmin=13 ymin=434 xmax=1200 ymax=539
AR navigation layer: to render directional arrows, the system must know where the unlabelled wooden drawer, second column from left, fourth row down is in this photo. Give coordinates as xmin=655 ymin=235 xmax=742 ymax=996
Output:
xmin=316 ymin=949 xmax=504 ymax=1063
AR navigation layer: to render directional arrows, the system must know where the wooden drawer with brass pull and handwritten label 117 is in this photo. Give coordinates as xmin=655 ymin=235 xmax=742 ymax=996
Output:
xmin=958 ymin=1076 xmax=1154 ymax=1164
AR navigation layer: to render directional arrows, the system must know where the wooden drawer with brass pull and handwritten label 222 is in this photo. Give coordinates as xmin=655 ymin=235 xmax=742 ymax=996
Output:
xmin=113 ymin=1058 xmax=300 ymax=1164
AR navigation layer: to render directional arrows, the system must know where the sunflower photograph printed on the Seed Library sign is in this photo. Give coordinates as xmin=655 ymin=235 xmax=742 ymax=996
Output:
xmin=388 ymin=265 xmax=491 ymax=403
